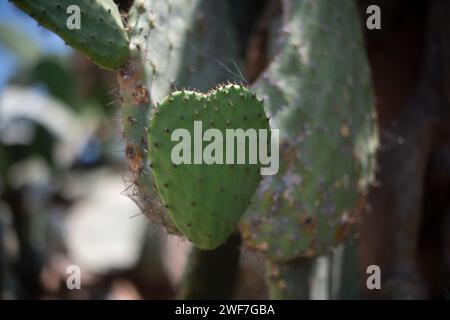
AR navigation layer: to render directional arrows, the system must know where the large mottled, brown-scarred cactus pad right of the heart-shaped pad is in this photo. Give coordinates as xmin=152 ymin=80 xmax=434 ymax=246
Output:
xmin=241 ymin=0 xmax=378 ymax=261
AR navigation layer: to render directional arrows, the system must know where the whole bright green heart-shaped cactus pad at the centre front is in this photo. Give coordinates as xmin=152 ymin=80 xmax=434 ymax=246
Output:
xmin=148 ymin=85 xmax=271 ymax=250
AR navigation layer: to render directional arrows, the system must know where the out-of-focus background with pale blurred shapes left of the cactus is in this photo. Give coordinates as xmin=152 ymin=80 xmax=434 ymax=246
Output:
xmin=0 ymin=1 xmax=181 ymax=299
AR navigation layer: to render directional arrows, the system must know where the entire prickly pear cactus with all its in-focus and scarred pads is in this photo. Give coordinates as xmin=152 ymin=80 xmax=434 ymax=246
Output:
xmin=13 ymin=0 xmax=378 ymax=297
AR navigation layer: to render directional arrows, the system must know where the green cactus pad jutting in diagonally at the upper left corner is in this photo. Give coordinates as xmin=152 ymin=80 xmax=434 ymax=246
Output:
xmin=12 ymin=0 xmax=129 ymax=70
